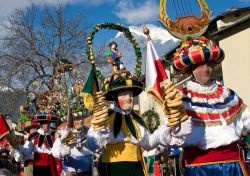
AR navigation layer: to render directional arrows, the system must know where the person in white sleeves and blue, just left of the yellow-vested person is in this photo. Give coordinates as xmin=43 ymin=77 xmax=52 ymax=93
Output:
xmin=52 ymin=123 xmax=93 ymax=176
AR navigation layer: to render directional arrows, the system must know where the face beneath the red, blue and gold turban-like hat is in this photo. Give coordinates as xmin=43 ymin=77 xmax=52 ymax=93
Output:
xmin=192 ymin=62 xmax=213 ymax=85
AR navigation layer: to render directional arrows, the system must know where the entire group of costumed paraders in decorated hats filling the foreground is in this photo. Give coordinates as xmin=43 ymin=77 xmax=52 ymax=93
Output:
xmin=0 ymin=34 xmax=250 ymax=176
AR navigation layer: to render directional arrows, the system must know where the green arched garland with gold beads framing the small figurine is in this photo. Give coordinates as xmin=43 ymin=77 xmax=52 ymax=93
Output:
xmin=86 ymin=23 xmax=142 ymax=82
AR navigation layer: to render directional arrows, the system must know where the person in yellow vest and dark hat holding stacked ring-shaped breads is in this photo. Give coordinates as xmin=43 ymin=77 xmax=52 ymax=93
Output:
xmin=88 ymin=71 xmax=191 ymax=176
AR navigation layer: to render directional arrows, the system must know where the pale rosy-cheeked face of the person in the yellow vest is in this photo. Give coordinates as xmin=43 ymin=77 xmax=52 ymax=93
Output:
xmin=117 ymin=91 xmax=134 ymax=111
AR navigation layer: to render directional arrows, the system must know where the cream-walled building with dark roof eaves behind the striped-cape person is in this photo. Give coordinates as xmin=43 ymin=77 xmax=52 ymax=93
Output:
xmin=207 ymin=7 xmax=250 ymax=106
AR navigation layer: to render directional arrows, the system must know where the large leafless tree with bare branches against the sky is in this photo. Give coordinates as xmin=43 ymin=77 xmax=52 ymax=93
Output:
xmin=0 ymin=3 xmax=88 ymax=116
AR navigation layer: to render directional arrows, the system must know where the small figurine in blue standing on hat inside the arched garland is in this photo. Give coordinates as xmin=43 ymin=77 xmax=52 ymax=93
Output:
xmin=106 ymin=41 xmax=125 ymax=73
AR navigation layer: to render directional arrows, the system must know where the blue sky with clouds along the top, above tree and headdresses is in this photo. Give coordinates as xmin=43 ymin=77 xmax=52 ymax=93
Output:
xmin=0 ymin=0 xmax=250 ymax=42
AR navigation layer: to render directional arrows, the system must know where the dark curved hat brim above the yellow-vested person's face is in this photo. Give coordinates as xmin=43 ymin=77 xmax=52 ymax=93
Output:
xmin=104 ymin=85 xmax=143 ymax=101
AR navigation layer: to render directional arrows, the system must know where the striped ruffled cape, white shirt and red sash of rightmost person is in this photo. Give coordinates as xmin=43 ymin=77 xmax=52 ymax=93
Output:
xmin=180 ymin=81 xmax=250 ymax=175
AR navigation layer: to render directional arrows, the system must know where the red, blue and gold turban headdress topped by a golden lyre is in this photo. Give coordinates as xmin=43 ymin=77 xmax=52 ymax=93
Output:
xmin=159 ymin=0 xmax=224 ymax=71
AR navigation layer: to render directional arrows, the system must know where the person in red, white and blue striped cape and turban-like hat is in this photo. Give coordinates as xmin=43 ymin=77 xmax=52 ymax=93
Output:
xmin=170 ymin=37 xmax=250 ymax=176
